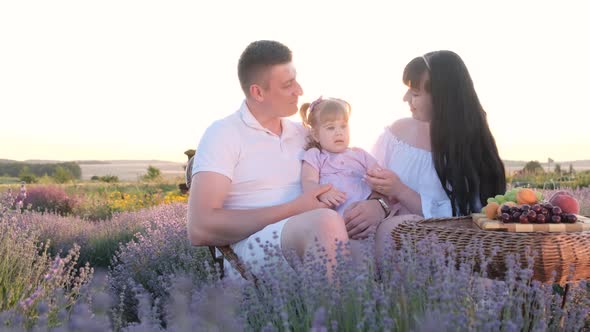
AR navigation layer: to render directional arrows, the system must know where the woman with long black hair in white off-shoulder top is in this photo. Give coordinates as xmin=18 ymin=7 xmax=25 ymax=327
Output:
xmin=345 ymin=51 xmax=506 ymax=254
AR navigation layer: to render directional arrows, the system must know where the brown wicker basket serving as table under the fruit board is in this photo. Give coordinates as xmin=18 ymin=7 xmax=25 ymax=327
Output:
xmin=392 ymin=216 xmax=590 ymax=284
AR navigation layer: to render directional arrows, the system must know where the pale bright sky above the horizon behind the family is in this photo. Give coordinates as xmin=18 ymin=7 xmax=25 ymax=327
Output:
xmin=0 ymin=0 xmax=590 ymax=162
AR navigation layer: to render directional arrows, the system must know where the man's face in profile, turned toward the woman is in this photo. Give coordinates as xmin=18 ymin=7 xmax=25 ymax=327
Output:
xmin=263 ymin=62 xmax=303 ymax=117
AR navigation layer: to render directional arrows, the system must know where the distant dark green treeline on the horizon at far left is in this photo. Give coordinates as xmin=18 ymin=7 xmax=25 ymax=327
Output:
xmin=0 ymin=162 xmax=82 ymax=179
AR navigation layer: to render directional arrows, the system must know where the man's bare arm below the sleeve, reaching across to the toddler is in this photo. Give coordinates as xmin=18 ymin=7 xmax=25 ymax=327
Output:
xmin=188 ymin=172 xmax=331 ymax=246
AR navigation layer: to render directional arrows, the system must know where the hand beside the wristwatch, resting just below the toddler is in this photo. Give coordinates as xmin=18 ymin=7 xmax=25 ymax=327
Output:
xmin=343 ymin=199 xmax=385 ymax=240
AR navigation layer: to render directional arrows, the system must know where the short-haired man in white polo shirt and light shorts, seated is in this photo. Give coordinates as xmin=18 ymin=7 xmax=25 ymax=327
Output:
xmin=188 ymin=41 xmax=366 ymax=271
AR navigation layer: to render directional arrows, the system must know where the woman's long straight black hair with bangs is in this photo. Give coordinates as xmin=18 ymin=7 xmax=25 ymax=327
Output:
xmin=403 ymin=51 xmax=506 ymax=216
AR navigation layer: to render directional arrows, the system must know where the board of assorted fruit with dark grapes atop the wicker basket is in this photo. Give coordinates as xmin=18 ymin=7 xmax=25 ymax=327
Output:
xmin=472 ymin=188 xmax=590 ymax=232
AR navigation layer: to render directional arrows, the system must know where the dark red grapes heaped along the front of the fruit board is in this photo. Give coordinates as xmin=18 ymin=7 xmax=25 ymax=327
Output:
xmin=499 ymin=203 xmax=578 ymax=224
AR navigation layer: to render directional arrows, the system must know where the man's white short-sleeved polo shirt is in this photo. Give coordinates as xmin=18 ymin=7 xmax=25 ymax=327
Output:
xmin=193 ymin=101 xmax=307 ymax=209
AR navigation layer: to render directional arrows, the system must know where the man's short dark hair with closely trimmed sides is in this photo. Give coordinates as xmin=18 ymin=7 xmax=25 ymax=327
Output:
xmin=238 ymin=40 xmax=292 ymax=96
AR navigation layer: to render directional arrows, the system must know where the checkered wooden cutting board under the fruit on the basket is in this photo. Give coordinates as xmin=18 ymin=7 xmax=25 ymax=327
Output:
xmin=471 ymin=213 xmax=590 ymax=233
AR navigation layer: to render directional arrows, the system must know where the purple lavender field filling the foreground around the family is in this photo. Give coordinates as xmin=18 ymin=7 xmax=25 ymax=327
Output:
xmin=0 ymin=188 xmax=590 ymax=331
